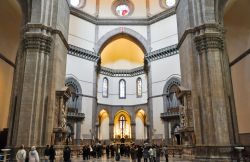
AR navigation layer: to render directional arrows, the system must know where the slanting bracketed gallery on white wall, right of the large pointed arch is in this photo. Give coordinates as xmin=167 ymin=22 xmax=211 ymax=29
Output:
xmin=146 ymin=44 xmax=179 ymax=61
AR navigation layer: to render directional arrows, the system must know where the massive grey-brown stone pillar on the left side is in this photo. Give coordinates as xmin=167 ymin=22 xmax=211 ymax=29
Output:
xmin=8 ymin=0 xmax=69 ymax=146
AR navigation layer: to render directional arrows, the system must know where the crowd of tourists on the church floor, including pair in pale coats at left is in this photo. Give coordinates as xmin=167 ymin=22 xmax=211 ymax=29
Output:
xmin=16 ymin=143 xmax=168 ymax=162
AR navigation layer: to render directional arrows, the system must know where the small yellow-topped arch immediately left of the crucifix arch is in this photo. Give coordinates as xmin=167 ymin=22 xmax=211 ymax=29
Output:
xmin=98 ymin=109 xmax=109 ymax=140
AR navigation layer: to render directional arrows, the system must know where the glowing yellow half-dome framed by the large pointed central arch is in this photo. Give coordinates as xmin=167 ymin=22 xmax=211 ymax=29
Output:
xmin=100 ymin=34 xmax=144 ymax=69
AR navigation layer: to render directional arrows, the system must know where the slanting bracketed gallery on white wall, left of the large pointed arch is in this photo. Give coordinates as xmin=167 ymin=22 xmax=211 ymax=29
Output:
xmin=68 ymin=45 xmax=99 ymax=62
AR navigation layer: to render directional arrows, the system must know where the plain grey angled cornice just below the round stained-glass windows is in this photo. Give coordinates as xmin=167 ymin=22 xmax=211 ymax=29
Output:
xmin=70 ymin=7 xmax=176 ymax=25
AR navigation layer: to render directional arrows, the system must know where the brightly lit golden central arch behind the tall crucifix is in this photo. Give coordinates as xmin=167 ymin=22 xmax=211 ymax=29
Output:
xmin=114 ymin=110 xmax=131 ymax=139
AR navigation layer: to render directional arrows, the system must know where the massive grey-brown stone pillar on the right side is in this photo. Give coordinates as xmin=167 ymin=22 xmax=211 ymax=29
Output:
xmin=177 ymin=0 xmax=238 ymax=161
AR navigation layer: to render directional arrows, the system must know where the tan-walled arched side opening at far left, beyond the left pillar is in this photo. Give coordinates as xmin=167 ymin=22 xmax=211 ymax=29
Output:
xmin=0 ymin=0 xmax=22 ymax=148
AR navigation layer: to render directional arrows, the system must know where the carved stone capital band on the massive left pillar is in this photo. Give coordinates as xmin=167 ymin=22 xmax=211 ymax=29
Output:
xmin=24 ymin=32 xmax=52 ymax=54
